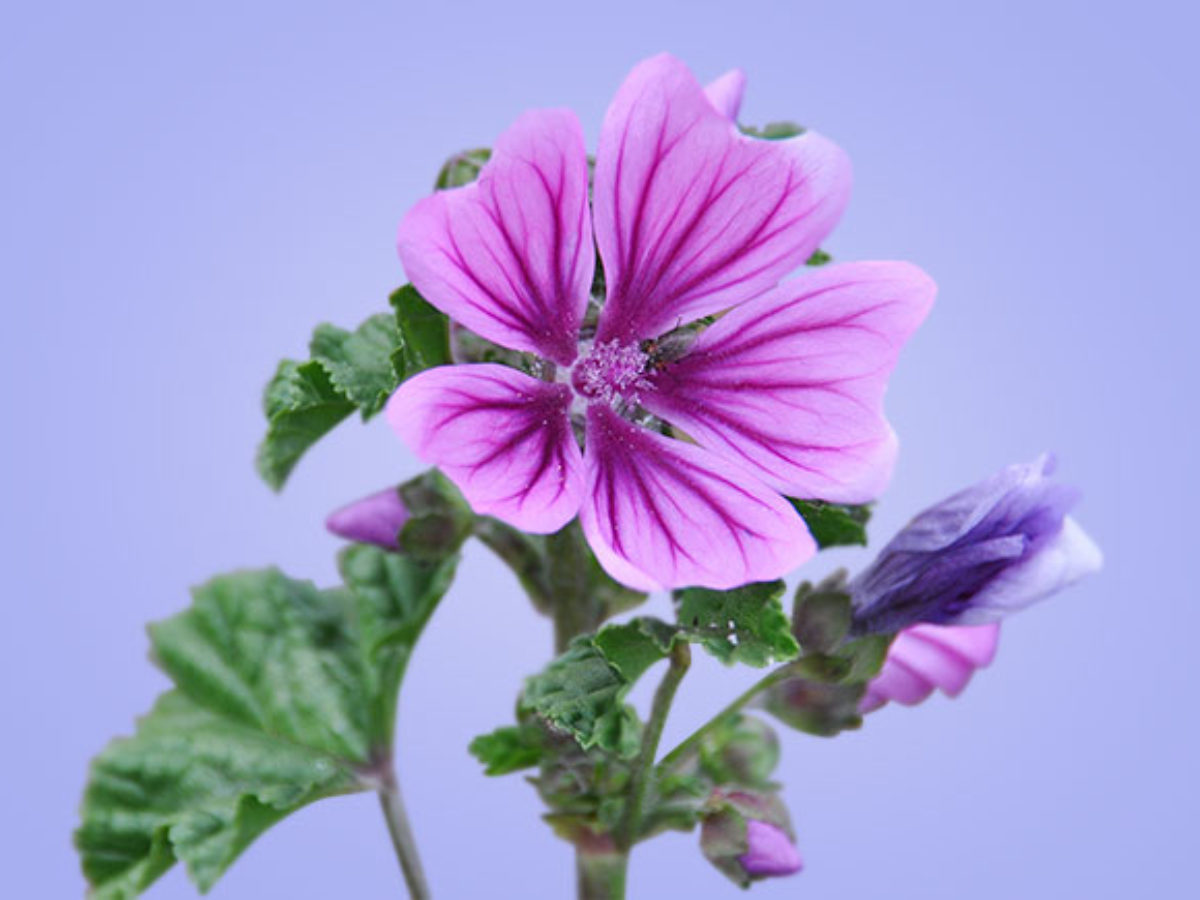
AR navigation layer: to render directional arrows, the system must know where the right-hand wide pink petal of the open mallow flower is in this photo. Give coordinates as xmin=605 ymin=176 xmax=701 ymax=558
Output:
xmin=643 ymin=263 xmax=935 ymax=503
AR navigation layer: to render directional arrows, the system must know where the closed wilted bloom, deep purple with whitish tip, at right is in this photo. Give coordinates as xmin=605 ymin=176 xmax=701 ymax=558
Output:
xmin=848 ymin=456 xmax=1102 ymax=634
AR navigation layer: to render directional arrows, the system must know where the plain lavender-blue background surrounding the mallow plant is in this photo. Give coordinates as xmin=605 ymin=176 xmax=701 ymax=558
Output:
xmin=0 ymin=0 xmax=1200 ymax=900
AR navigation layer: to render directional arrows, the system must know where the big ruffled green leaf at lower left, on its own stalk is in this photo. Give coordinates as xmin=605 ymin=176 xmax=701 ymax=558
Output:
xmin=76 ymin=546 xmax=456 ymax=898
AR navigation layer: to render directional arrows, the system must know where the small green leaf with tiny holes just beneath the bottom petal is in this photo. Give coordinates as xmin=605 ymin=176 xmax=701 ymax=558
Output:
xmin=674 ymin=581 xmax=800 ymax=666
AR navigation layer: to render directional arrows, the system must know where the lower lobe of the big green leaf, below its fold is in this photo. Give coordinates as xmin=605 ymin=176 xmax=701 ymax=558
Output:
xmin=76 ymin=691 xmax=350 ymax=900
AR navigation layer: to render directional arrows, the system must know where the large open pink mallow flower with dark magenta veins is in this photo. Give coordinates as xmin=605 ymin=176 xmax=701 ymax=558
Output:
xmin=388 ymin=55 xmax=935 ymax=589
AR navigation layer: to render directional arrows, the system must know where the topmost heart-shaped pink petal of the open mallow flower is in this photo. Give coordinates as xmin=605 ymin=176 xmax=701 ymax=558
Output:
xmin=594 ymin=54 xmax=850 ymax=341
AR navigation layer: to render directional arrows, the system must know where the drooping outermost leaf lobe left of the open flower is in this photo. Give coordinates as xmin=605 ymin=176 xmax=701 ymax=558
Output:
xmin=258 ymin=360 xmax=354 ymax=491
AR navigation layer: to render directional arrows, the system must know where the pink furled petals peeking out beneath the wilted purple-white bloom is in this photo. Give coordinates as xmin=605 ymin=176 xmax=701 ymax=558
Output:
xmin=859 ymin=624 xmax=1000 ymax=713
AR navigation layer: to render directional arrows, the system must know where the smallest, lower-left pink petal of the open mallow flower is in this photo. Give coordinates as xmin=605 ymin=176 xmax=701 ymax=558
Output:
xmin=388 ymin=364 xmax=583 ymax=534
